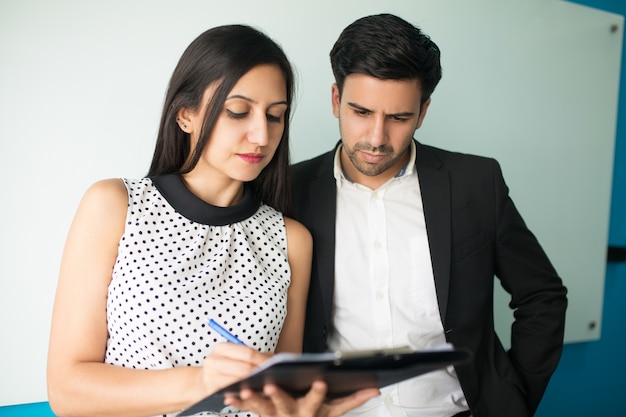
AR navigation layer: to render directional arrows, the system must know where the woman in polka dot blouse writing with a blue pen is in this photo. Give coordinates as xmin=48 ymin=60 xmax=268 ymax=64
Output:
xmin=48 ymin=25 xmax=376 ymax=416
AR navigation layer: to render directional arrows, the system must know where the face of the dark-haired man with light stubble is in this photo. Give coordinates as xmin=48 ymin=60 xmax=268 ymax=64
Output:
xmin=332 ymin=74 xmax=430 ymax=189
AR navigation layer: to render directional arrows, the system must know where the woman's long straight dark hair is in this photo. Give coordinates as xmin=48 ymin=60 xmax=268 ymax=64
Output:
xmin=148 ymin=25 xmax=295 ymax=214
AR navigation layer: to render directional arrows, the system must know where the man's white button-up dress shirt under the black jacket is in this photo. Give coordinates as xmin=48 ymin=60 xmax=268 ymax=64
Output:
xmin=329 ymin=143 xmax=468 ymax=417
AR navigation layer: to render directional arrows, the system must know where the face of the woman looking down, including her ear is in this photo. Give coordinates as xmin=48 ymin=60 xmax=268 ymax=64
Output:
xmin=183 ymin=64 xmax=288 ymax=182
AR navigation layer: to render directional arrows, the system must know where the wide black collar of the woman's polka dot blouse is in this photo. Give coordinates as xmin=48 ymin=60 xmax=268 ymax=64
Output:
xmin=150 ymin=174 xmax=261 ymax=226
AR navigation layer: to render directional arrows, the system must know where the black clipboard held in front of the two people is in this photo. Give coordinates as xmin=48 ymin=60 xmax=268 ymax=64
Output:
xmin=178 ymin=345 xmax=471 ymax=417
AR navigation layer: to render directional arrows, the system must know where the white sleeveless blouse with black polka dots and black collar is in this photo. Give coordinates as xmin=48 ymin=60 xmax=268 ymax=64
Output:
xmin=105 ymin=175 xmax=290 ymax=415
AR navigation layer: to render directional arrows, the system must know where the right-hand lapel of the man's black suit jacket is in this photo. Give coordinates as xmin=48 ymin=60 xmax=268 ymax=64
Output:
xmin=415 ymin=143 xmax=452 ymax=326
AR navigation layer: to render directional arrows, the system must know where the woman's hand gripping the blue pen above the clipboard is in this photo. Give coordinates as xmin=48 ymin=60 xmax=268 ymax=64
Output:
xmin=202 ymin=343 xmax=272 ymax=397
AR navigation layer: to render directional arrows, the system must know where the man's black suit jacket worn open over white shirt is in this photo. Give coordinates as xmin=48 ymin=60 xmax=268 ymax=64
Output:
xmin=293 ymin=142 xmax=567 ymax=417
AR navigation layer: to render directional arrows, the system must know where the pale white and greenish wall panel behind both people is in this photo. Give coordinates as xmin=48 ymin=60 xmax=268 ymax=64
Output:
xmin=0 ymin=0 xmax=623 ymax=405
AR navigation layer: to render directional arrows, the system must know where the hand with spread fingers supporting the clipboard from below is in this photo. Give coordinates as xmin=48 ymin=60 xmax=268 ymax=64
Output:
xmin=224 ymin=381 xmax=380 ymax=417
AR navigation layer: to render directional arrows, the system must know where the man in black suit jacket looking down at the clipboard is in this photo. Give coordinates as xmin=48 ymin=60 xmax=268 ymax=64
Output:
xmin=293 ymin=14 xmax=567 ymax=417
